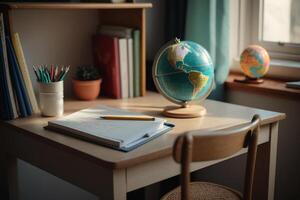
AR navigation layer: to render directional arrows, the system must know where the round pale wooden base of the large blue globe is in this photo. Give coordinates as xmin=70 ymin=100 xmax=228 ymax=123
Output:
xmin=163 ymin=105 xmax=206 ymax=118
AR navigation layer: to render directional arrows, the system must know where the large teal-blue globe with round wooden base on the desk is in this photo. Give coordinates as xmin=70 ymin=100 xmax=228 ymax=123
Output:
xmin=152 ymin=38 xmax=214 ymax=118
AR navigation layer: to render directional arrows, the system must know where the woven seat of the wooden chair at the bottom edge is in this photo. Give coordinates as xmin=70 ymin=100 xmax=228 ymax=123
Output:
xmin=161 ymin=182 xmax=242 ymax=200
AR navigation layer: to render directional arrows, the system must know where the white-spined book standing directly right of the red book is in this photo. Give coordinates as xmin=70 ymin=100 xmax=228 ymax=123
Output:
xmin=119 ymin=38 xmax=129 ymax=98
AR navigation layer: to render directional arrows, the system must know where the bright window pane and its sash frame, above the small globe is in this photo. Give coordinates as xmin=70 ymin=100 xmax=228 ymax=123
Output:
xmin=252 ymin=0 xmax=300 ymax=60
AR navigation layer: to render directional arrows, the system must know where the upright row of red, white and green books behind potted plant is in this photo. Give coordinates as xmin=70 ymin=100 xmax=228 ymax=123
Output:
xmin=92 ymin=26 xmax=141 ymax=98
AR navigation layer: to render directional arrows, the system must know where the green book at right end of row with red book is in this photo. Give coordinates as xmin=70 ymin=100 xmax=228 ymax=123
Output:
xmin=133 ymin=30 xmax=141 ymax=97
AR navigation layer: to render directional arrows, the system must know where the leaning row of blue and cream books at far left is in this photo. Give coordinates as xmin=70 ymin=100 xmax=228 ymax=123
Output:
xmin=0 ymin=7 xmax=39 ymax=120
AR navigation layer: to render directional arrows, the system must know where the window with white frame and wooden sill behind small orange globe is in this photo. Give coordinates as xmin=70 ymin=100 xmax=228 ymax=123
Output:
xmin=229 ymin=0 xmax=300 ymax=80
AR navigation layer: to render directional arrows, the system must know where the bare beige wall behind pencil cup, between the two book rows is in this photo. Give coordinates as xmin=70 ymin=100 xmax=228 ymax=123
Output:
xmin=12 ymin=10 xmax=98 ymax=97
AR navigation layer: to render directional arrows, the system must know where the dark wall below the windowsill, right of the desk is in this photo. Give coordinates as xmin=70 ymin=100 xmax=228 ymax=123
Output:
xmin=228 ymin=91 xmax=300 ymax=200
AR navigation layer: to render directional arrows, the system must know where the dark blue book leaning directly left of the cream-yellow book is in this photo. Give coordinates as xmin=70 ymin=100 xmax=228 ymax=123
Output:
xmin=6 ymin=36 xmax=32 ymax=117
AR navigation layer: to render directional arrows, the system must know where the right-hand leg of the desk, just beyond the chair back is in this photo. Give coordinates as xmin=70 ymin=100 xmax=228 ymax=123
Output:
xmin=253 ymin=123 xmax=278 ymax=200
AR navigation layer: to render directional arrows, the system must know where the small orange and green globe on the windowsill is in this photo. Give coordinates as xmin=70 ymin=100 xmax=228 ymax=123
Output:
xmin=240 ymin=45 xmax=270 ymax=79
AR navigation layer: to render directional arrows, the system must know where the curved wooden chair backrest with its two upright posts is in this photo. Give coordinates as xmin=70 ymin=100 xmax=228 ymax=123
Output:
xmin=173 ymin=115 xmax=260 ymax=200
